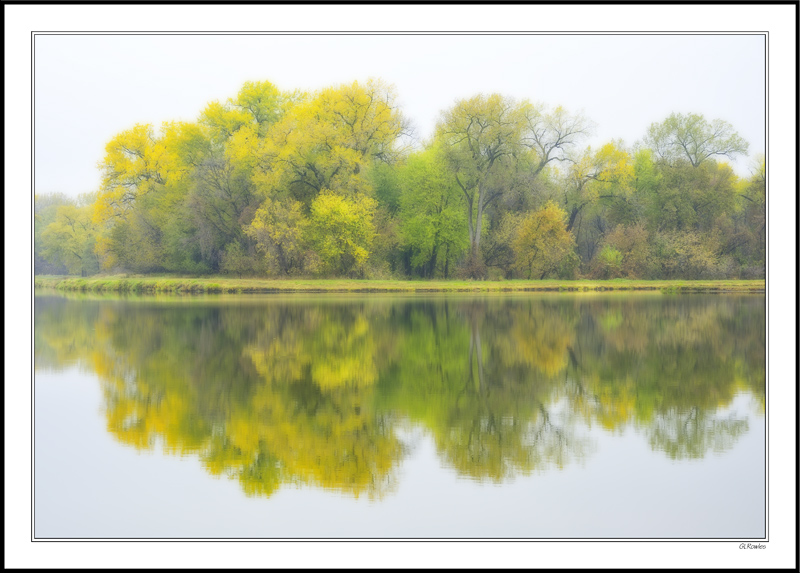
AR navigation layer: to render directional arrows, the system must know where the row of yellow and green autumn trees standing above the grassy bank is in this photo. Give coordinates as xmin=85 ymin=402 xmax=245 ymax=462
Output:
xmin=34 ymin=80 xmax=766 ymax=279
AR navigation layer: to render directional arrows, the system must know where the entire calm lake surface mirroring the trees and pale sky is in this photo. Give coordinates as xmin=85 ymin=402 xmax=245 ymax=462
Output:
xmin=34 ymin=293 xmax=766 ymax=538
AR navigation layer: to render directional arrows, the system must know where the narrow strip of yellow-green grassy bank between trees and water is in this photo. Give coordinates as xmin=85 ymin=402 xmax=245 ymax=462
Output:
xmin=34 ymin=276 xmax=765 ymax=294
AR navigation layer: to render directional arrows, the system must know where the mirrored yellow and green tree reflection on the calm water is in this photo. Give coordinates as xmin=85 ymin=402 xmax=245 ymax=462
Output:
xmin=35 ymin=296 xmax=765 ymax=498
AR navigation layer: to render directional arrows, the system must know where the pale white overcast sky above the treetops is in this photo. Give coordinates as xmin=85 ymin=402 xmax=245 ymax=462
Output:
xmin=35 ymin=35 xmax=765 ymax=195
